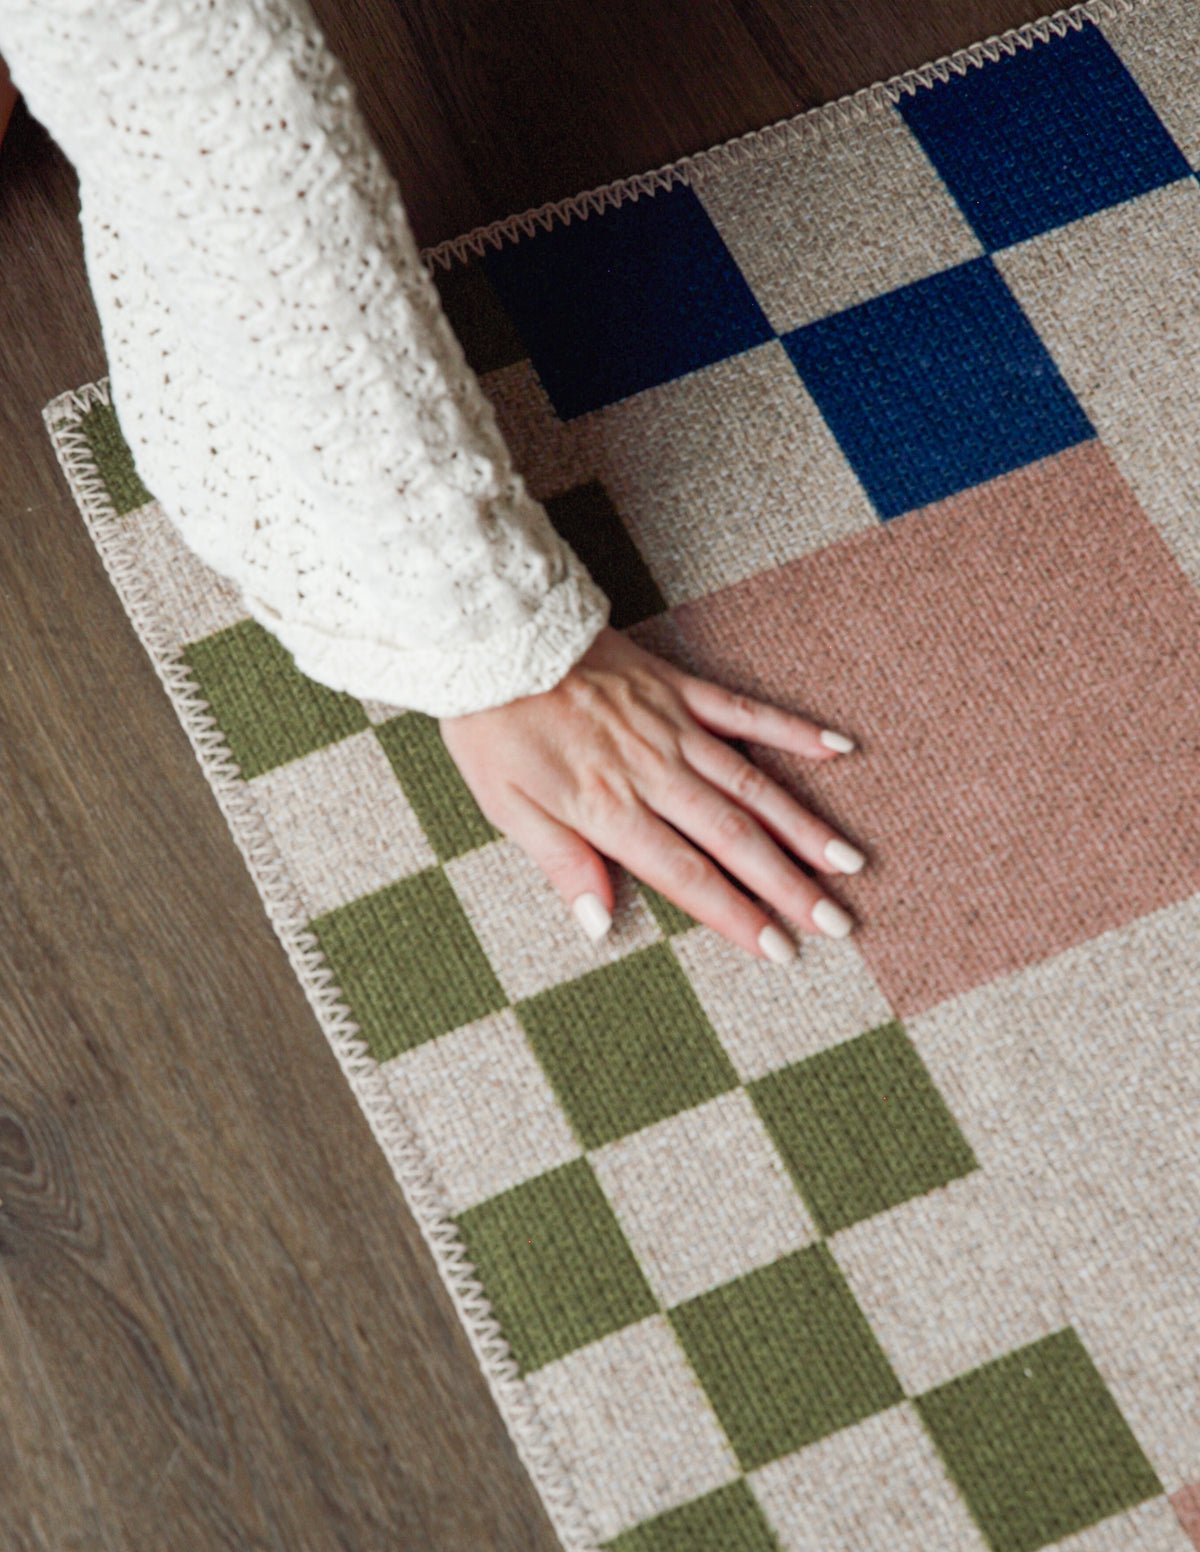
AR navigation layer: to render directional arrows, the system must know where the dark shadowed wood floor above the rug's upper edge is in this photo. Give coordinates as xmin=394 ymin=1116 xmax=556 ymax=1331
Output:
xmin=322 ymin=0 xmax=1046 ymax=245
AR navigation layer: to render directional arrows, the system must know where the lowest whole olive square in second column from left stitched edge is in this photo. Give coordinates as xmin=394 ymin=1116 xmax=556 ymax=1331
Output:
xmin=668 ymin=1243 xmax=903 ymax=1471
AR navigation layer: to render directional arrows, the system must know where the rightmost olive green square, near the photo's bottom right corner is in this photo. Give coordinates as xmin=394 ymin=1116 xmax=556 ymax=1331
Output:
xmin=916 ymin=1325 xmax=1163 ymax=1552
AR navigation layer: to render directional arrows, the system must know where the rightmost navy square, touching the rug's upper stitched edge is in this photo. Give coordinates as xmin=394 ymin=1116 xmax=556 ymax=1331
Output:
xmin=897 ymin=22 xmax=1191 ymax=248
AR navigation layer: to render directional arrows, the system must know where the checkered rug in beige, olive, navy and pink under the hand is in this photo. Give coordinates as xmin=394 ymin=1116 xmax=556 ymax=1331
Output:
xmin=45 ymin=0 xmax=1200 ymax=1552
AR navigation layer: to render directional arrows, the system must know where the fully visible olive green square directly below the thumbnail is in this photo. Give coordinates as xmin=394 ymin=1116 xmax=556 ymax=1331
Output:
xmin=515 ymin=944 xmax=737 ymax=1148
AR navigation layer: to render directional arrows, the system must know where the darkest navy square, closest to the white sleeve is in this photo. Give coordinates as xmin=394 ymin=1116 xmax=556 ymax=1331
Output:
xmin=483 ymin=185 xmax=775 ymax=421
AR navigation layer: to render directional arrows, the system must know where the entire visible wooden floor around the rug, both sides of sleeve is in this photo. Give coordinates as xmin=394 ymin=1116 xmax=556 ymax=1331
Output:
xmin=0 ymin=0 xmax=1048 ymax=1552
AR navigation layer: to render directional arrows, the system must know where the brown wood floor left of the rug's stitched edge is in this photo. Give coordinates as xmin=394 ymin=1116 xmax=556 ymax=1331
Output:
xmin=0 ymin=100 xmax=556 ymax=1552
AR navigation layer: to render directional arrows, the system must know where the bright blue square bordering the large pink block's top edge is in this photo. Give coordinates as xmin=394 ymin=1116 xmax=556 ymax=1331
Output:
xmin=782 ymin=259 xmax=1096 ymax=518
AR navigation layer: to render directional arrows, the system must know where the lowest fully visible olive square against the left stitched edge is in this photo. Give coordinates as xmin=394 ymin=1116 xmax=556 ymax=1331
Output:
xmin=456 ymin=1159 xmax=658 ymax=1374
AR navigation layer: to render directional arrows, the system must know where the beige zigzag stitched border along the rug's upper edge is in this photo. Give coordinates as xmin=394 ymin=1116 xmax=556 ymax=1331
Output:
xmin=421 ymin=0 xmax=1152 ymax=270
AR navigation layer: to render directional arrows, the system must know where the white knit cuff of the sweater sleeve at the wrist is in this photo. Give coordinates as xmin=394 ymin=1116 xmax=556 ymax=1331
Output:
xmin=242 ymin=542 xmax=610 ymax=717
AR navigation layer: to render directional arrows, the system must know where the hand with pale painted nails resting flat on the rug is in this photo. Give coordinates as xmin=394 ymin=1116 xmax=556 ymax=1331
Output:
xmin=438 ymin=625 xmax=865 ymax=962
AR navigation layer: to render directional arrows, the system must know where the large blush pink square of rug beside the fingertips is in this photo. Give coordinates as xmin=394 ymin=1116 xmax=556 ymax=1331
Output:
xmin=672 ymin=442 xmax=1200 ymax=1017
